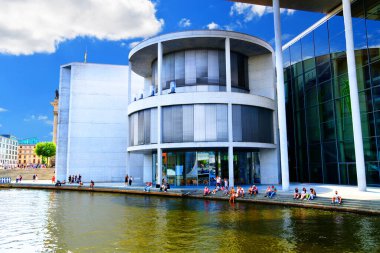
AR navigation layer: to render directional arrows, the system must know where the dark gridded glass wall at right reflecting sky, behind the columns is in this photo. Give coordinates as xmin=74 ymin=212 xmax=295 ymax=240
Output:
xmin=284 ymin=0 xmax=380 ymax=185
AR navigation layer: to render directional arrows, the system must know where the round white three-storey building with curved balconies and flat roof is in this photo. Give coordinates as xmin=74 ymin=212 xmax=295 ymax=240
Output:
xmin=127 ymin=30 xmax=279 ymax=186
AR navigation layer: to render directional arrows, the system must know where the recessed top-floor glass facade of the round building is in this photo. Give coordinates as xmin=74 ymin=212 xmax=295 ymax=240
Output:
xmin=152 ymin=49 xmax=249 ymax=93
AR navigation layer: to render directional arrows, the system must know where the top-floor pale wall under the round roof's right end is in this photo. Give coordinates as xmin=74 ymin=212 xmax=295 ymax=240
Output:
xmin=248 ymin=54 xmax=275 ymax=99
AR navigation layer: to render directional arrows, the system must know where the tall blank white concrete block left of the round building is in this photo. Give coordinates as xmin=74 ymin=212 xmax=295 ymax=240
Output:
xmin=57 ymin=63 xmax=128 ymax=182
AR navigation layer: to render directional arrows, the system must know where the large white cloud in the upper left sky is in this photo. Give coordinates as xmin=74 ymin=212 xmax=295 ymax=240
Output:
xmin=0 ymin=0 xmax=164 ymax=55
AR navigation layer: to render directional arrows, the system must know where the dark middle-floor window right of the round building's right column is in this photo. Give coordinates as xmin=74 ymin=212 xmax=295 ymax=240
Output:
xmin=232 ymin=105 xmax=273 ymax=143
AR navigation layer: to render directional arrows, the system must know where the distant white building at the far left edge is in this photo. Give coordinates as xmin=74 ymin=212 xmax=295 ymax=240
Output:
xmin=0 ymin=134 xmax=18 ymax=169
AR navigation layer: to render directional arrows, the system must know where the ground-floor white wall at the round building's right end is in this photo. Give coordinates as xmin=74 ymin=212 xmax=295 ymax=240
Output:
xmin=259 ymin=148 xmax=280 ymax=184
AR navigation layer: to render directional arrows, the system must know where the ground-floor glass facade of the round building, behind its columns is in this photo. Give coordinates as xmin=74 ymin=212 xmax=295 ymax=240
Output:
xmin=153 ymin=149 xmax=260 ymax=186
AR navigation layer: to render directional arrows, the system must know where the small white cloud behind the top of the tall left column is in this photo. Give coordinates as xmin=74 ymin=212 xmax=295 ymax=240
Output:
xmin=230 ymin=3 xmax=295 ymax=22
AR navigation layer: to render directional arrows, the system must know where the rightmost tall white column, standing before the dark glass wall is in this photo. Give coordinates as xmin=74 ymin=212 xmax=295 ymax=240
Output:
xmin=342 ymin=0 xmax=367 ymax=191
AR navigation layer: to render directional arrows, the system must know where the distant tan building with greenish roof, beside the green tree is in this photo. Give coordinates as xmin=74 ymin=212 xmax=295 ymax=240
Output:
xmin=18 ymin=138 xmax=41 ymax=167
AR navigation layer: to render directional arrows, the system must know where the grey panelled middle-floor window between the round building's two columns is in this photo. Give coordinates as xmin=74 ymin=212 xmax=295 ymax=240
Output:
xmin=162 ymin=104 xmax=228 ymax=143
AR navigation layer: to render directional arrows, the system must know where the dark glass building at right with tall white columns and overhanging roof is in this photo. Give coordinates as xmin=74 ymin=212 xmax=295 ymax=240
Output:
xmin=233 ymin=0 xmax=380 ymax=191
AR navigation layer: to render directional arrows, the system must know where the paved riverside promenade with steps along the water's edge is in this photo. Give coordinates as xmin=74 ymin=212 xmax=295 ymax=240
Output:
xmin=0 ymin=180 xmax=380 ymax=215
